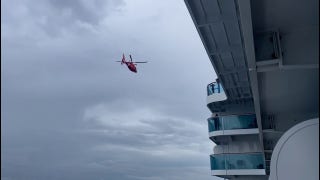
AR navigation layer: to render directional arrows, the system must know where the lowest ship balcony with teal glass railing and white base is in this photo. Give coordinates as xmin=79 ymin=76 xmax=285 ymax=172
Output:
xmin=210 ymin=153 xmax=266 ymax=177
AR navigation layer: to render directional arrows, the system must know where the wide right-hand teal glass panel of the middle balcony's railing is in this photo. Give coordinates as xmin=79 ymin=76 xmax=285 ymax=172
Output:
xmin=221 ymin=114 xmax=258 ymax=130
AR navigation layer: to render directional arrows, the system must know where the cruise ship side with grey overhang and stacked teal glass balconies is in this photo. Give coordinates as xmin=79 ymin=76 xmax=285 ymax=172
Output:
xmin=185 ymin=0 xmax=319 ymax=180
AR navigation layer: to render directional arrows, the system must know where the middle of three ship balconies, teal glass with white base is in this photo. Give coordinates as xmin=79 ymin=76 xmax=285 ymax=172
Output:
xmin=208 ymin=114 xmax=259 ymax=144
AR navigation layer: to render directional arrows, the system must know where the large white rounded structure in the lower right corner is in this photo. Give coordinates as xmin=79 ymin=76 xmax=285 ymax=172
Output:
xmin=269 ymin=118 xmax=319 ymax=180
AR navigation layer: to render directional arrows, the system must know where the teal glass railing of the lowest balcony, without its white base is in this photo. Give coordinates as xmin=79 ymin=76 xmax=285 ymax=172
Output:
xmin=210 ymin=153 xmax=265 ymax=170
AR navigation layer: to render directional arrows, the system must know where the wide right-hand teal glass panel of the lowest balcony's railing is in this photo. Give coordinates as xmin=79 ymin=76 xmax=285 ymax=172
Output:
xmin=227 ymin=154 xmax=264 ymax=169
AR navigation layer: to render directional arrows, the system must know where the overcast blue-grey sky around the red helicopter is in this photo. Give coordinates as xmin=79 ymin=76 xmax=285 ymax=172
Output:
xmin=1 ymin=0 xmax=218 ymax=180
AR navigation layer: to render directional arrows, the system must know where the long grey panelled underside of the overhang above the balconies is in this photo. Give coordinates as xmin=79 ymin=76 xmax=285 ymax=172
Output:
xmin=185 ymin=0 xmax=252 ymax=102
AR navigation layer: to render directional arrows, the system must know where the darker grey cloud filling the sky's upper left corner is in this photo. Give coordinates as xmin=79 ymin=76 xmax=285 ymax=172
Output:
xmin=1 ymin=0 xmax=125 ymax=38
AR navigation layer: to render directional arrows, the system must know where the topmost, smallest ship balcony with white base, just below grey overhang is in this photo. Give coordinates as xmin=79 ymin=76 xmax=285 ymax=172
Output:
xmin=207 ymin=82 xmax=227 ymax=104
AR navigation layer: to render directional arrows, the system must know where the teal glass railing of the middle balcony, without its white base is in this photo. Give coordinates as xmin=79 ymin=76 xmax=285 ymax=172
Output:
xmin=208 ymin=114 xmax=258 ymax=132
